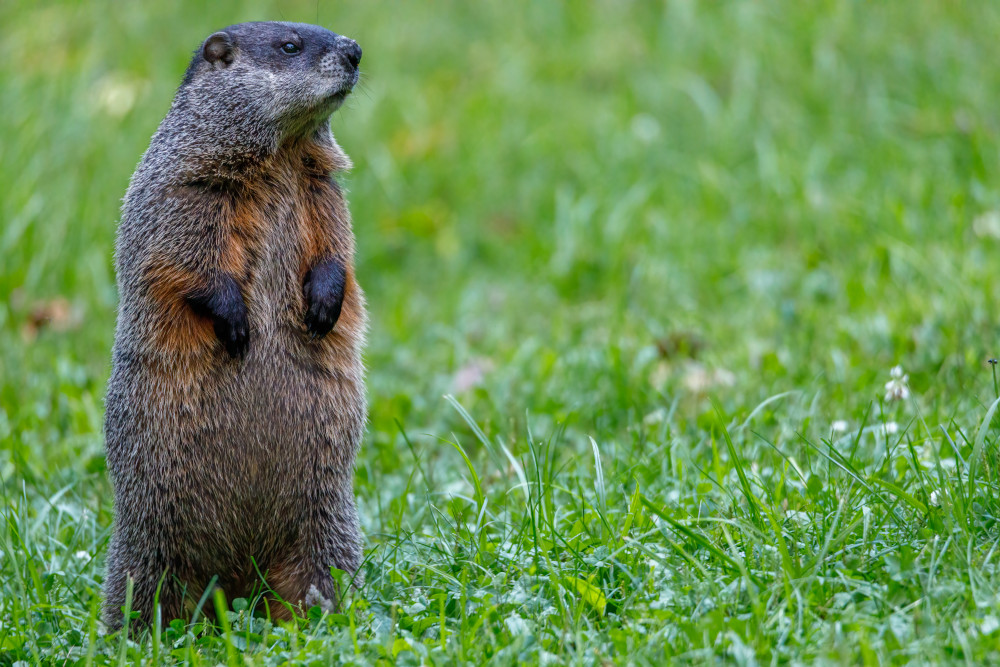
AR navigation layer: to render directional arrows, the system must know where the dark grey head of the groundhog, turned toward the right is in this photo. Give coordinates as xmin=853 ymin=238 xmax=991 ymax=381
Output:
xmin=182 ymin=22 xmax=361 ymax=136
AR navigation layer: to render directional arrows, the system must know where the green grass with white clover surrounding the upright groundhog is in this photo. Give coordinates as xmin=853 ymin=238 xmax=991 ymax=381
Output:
xmin=0 ymin=0 xmax=1000 ymax=665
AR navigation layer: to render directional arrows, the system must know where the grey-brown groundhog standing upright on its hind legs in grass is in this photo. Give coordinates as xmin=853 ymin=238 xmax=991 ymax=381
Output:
xmin=104 ymin=22 xmax=366 ymax=630
